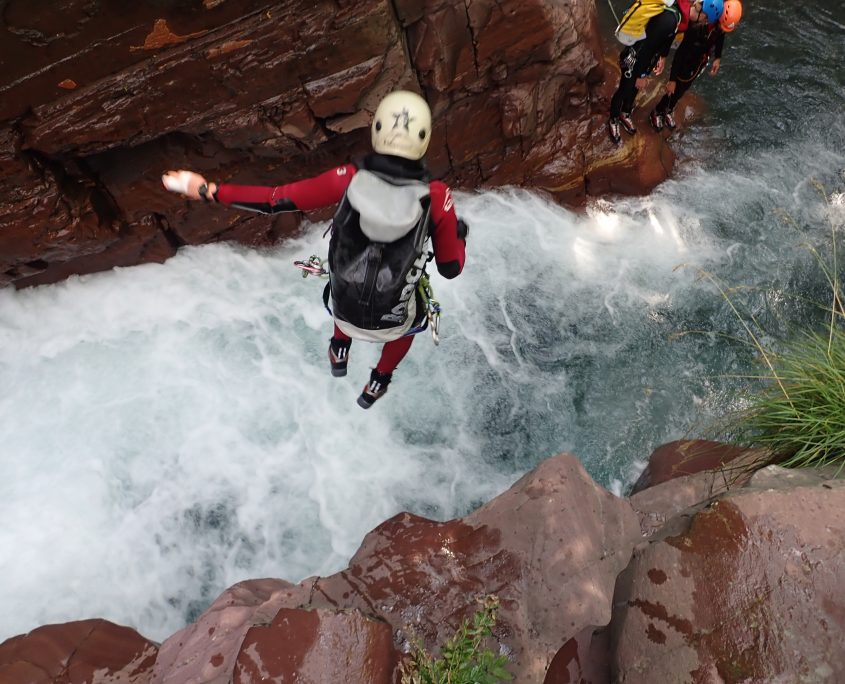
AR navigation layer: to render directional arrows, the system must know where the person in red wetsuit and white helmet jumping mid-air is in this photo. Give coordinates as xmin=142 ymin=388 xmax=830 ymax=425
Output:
xmin=162 ymin=90 xmax=468 ymax=409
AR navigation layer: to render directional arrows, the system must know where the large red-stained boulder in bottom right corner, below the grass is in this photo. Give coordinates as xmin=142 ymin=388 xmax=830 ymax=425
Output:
xmin=611 ymin=476 xmax=845 ymax=684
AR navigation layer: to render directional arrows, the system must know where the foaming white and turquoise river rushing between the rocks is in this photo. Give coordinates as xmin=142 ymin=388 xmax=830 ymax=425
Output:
xmin=0 ymin=2 xmax=845 ymax=640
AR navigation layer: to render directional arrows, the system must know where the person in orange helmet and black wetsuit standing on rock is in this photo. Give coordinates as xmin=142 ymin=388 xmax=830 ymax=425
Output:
xmin=649 ymin=0 xmax=742 ymax=131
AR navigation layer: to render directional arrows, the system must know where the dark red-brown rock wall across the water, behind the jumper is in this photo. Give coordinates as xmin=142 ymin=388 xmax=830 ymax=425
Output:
xmin=0 ymin=0 xmax=672 ymax=287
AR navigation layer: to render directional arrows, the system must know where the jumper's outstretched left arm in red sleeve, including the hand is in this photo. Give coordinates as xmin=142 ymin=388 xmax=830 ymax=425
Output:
xmin=162 ymin=164 xmax=355 ymax=214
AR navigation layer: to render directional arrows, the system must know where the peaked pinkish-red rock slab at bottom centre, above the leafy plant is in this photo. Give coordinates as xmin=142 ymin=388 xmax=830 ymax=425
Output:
xmin=298 ymin=454 xmax=640 ymax=682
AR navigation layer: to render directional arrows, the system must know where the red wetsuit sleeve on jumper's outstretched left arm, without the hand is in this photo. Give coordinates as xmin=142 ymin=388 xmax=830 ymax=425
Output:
xmin=216 ymin=164 xmax=355 ymax=214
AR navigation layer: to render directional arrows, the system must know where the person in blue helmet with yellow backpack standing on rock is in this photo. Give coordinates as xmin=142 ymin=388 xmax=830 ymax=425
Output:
xmin=607 ymin=0 xmax=723 ymax=144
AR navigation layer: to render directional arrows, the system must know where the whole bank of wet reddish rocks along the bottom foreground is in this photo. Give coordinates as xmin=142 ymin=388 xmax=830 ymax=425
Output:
xmin=0 ymin=441 xmax=845 ymax=684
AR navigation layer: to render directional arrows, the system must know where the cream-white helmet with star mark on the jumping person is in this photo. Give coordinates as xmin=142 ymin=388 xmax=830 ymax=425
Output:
xmin=372 ymin=90 xmax=431 ymax=159
